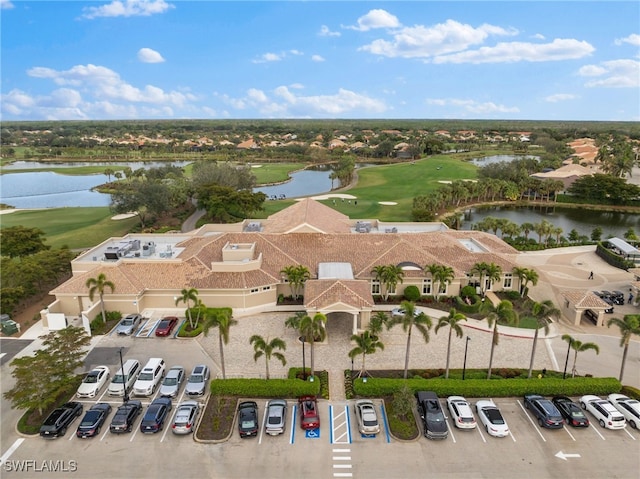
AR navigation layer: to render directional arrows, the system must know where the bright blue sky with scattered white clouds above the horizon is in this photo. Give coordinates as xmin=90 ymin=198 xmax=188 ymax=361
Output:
xmin=0 ymin=0 xmax=640 ymax=121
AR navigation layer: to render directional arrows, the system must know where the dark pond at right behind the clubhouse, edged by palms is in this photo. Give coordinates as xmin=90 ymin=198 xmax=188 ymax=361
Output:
xmin=462 ymin=205 xmax=640 ymax=238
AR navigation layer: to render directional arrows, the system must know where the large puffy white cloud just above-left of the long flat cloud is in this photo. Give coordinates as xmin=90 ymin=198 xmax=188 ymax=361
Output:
xmin=360 ymin=20 xmax=517 ymax=58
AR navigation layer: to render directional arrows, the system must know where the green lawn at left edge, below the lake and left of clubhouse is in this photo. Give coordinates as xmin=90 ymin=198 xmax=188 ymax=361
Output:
xmin=0 ymin=206 xmax=139 ymax=249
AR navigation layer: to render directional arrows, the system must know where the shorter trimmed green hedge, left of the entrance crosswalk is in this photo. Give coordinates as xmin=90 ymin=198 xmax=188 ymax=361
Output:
xmin=211 ymin=379 xmax=320 ymax=398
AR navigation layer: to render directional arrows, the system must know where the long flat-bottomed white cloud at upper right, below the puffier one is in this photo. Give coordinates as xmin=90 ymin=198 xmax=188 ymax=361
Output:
xmin=433 ymin=38 xmax=595 ymax=64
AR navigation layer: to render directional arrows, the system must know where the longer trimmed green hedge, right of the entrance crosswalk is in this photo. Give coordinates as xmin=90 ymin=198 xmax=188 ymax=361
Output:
xmin=353 ymin=377 xmax=622 ymax=398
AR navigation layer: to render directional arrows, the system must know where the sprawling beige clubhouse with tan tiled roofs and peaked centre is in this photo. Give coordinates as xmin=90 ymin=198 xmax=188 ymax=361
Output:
xmin=48 ymin=199 xmax=520 ymax=332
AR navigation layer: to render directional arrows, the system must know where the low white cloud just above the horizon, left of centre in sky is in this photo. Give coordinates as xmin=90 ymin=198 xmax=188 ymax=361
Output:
xmin=223 ymin=84 xmax=387 ymax=118
